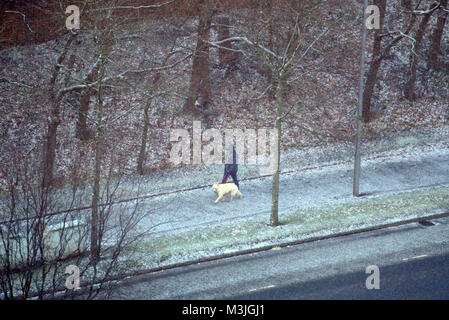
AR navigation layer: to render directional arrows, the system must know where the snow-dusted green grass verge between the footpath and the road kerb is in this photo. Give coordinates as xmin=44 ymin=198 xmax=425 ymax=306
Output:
xmin=121 ymin=186 xmax=449 ymax=270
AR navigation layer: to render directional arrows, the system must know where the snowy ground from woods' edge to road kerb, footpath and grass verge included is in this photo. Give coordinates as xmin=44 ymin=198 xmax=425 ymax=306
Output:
xmin=107 ymin=128 xmax=449 ymax=269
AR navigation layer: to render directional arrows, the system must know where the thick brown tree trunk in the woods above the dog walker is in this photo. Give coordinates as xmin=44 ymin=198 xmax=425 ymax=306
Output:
xmin=183 ymin=13 xmax=212 ymax=114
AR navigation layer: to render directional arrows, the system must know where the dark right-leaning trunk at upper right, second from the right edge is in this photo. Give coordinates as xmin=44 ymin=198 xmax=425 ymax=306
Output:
xmin=404 ymin=7 xmax=434 ymax=101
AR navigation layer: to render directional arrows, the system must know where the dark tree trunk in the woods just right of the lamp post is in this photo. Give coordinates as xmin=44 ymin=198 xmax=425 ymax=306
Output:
xmin=362 ymin=0 xmax=387 ymax=123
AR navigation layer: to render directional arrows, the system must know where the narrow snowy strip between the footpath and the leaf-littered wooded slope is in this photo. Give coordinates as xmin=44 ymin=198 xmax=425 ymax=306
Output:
xmin=86 ymin=125 xmax=449 ymax=201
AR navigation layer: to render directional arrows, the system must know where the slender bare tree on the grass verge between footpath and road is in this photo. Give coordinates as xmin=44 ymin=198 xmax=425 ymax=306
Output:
xmin=211 ymin=0 xmax=328 ymax=226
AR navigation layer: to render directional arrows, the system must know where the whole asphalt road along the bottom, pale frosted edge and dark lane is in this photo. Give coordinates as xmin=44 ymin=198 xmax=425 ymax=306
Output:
xmin=112 ymin=218 xmax=449 ymax=300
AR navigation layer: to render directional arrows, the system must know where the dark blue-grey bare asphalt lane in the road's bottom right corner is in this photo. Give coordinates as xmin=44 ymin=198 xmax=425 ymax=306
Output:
xmin=229 ymin=254 xmax=449 ymax=300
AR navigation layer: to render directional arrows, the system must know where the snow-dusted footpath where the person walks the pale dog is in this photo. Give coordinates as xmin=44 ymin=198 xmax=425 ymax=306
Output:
xmin=135 ymin=129 xmax=449 ymax=238
